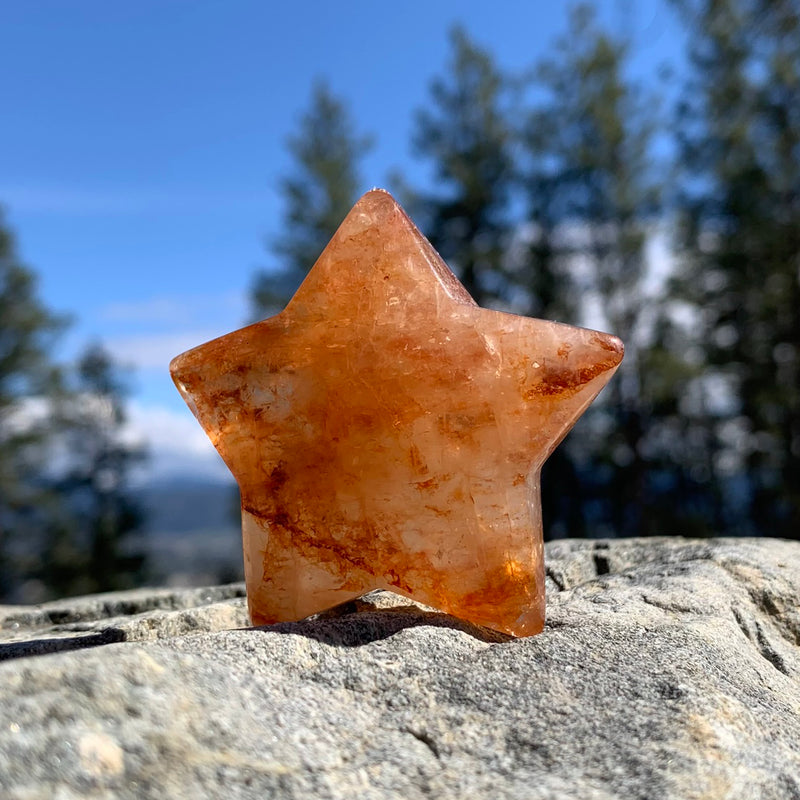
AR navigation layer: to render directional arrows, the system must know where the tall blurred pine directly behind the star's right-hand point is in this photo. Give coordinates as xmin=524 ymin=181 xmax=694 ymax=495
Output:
xmin=522 ymin=5 xmax=659 ymax=535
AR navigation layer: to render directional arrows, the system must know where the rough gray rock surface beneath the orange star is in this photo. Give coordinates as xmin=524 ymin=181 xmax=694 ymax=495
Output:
xmin=0 ymin=539 xmax=800 ymax=800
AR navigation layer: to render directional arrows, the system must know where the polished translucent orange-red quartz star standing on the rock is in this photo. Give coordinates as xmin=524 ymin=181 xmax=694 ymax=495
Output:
xmin=171 ymin=190 xmax=622 ymax=636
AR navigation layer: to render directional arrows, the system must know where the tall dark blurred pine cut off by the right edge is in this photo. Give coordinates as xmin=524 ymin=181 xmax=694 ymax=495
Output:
xmin=676 ymin=0 xmax=800 ymax=538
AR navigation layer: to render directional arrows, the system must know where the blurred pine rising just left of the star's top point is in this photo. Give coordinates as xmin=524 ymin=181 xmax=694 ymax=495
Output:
xmin=251 ymin=82 xmax=371 ymax=317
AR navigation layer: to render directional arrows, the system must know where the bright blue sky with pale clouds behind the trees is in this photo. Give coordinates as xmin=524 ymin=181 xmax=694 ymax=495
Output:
xmin=0 ymin=0 xmax=680 ymax=482
